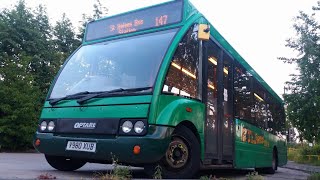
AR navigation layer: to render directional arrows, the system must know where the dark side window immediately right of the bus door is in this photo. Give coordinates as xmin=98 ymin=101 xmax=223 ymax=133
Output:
xmin=233 ymin=63 xmax=254 ymax=124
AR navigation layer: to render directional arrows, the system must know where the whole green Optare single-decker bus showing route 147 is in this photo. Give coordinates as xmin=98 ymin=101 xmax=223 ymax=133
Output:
xmin=34 ymin=0 xmax=287 ymax=178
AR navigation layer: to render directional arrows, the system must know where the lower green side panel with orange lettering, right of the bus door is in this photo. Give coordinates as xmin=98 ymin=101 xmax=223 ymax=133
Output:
xmin=235 ymin=119 xmax=273 ymax=168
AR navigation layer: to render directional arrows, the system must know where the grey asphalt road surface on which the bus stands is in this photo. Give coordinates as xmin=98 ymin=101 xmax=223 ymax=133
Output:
xmin=0 ymin=153 xmax=309 ymax=180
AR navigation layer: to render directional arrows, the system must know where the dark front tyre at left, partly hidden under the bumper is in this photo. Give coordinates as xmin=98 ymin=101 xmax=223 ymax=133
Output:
xmin=45 ymin=155 xmax=86 ymax=171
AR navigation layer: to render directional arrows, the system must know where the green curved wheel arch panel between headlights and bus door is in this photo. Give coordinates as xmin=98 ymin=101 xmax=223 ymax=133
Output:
xmin=156 ymin=95 xmax=205 ymax=158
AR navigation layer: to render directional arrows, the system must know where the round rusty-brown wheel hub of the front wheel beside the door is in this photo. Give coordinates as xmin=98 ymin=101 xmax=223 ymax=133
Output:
xmin=166 ymin=138 xmax=189 ymax=168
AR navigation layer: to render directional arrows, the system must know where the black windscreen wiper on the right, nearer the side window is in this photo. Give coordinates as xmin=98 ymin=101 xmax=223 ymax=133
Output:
xmin=77 ymin=87 xmax=152 ymax=104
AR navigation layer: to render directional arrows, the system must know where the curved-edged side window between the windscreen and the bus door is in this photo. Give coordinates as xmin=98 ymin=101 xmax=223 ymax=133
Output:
xmin=163 ymin=24 xmax=199 ymax=98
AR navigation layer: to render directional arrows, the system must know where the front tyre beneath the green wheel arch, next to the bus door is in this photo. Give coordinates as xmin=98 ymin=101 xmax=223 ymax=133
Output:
xmin=145 ymin=126 xmax=200 ymax=179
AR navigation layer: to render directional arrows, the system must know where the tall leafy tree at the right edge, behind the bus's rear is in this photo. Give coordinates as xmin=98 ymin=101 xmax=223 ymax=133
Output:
xmin=280 ymin=1 xmax=320 ymax=143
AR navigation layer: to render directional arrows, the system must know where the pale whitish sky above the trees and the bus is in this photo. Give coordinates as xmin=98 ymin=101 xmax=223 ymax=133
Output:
xmin=0 ymin=0 xmax=317 ymax=97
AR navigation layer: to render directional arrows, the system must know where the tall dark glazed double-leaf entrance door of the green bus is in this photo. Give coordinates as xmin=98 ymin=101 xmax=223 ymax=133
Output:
xmin=203 ymin=41 xmax=233 ymax=164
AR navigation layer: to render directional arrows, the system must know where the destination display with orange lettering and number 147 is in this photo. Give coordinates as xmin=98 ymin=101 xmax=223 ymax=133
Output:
xmin=85 ymin=0 xmax=183 ymax=41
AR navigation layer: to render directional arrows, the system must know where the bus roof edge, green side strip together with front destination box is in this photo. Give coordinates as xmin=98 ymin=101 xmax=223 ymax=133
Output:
xmin=83 ymin=0 xmax=284 ymax=104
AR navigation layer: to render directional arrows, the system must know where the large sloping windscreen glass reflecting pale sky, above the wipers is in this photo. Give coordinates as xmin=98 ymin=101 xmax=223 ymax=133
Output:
xmin=50 ymin=30 xmax=176 ymax=99
